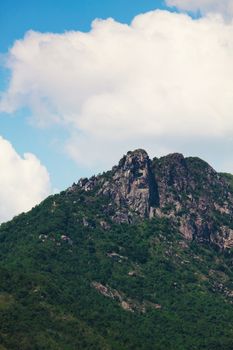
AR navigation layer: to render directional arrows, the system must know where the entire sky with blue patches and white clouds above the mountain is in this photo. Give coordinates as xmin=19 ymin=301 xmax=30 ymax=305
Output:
xmin=0 ymin=0 xmax=233 ymax=222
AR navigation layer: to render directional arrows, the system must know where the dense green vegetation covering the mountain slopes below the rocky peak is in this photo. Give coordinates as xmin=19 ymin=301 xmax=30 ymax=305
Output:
xmin=0 ymin=182 xmax=233 ymax=350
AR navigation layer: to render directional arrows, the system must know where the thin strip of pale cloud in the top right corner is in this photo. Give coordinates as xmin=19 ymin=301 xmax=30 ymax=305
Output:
xmin=165 ymin=0 xmax=233 ymax=18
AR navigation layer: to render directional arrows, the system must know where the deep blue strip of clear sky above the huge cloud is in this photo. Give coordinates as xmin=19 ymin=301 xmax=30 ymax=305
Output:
xmin=0 ymin=0 xmax=166 ymax=52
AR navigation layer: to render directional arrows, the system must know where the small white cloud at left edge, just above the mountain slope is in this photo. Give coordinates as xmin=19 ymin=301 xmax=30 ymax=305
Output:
xmin=0 ymin=136 xmax=51 ymax=222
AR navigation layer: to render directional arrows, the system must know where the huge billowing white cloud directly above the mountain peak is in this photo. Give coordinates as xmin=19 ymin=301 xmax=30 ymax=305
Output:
xmin=0 ymin=11 xmax=233 ymax=170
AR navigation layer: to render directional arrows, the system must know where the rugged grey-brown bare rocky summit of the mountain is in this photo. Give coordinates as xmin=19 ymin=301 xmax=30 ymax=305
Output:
xmin=75 ymin=149 xmax=233 ymax=248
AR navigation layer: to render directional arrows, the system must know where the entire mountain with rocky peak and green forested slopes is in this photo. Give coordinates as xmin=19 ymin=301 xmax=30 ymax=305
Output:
xmin=0 ymin=149 xmax=233 ymax=350
